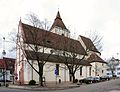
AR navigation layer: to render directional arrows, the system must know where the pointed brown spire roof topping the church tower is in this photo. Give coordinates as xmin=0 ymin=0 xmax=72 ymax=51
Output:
xmin=50 ymin=11 xmax=68 ymax=30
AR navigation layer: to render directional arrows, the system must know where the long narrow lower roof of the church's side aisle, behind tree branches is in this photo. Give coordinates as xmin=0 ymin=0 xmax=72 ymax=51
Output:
xmin=25 ymin=50 xmax=91 ymax=66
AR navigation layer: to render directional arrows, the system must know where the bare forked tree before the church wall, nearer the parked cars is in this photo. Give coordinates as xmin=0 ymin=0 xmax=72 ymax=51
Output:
xmin=55 ymin=38 xmax=90 ymax=83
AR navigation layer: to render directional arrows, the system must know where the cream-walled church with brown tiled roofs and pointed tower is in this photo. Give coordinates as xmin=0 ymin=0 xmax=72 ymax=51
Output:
xmin=16 ymin=11 xmax=105 ymax=84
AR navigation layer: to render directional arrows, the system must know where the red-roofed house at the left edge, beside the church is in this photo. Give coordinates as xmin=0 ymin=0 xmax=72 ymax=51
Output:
xmin=0 ymin=57 xmax=15 ymax=82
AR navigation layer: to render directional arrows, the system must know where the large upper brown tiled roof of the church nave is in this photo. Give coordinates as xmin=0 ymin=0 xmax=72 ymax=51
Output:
xmin=21 ymin=23 xmax=86 ymax=55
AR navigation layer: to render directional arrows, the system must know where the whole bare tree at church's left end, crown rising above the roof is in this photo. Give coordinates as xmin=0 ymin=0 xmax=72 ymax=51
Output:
xmin=10 ymin=13 xmax=52 ymax=86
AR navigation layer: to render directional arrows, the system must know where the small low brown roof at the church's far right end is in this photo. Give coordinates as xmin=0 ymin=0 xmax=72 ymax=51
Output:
xmin=87 ymin=53 xmax=106 ymax=63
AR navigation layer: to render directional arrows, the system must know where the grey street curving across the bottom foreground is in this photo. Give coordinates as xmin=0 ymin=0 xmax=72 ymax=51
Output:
xmin=0 ymin=79 xmax=120 ymax=92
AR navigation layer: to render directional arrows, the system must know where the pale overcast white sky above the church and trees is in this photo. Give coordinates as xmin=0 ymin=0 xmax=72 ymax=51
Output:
xmin=0 ymin=0 xmax=120 ymax=59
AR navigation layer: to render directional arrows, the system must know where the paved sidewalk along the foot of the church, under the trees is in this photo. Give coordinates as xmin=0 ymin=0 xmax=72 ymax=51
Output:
xmin=8 ymin=82 xmax=80 ymax=91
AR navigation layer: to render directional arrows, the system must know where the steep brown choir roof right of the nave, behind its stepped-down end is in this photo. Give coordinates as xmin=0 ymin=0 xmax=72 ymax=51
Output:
xmin=80 ymin=35 xmax=100 ymax=53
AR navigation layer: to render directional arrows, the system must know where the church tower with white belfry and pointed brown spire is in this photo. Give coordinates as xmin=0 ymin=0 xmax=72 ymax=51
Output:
xmin=50 ymin=11 xmax=70 ymax=37
